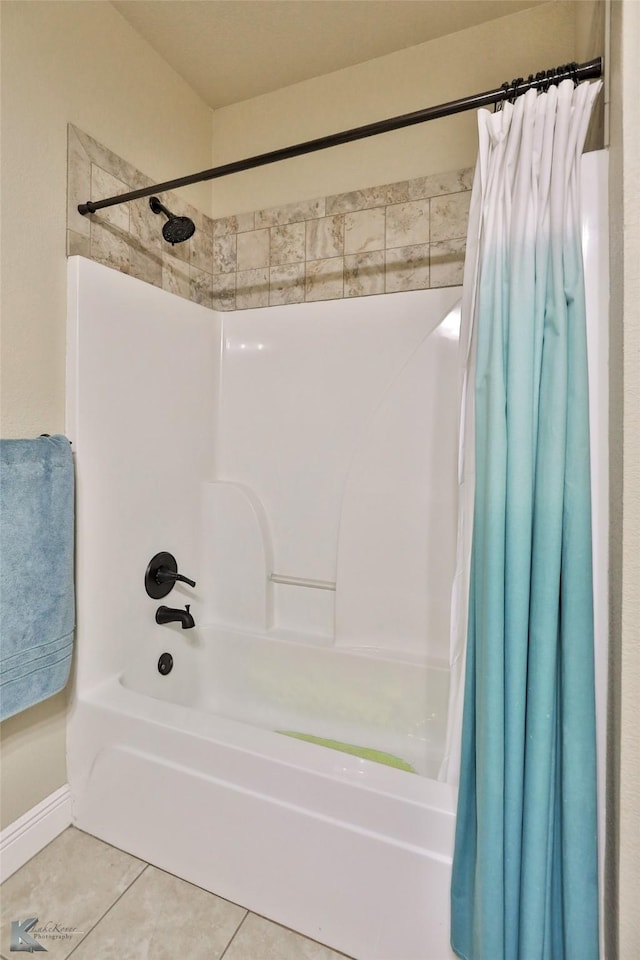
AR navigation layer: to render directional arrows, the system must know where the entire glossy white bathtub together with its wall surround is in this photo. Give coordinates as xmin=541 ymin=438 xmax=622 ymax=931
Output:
xmin=67 ymin=257 xmax=460 ymax=960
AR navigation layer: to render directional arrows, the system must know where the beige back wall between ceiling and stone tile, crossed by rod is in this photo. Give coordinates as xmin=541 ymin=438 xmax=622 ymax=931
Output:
xmin=213 ymin=0 xmax=576 ymax=217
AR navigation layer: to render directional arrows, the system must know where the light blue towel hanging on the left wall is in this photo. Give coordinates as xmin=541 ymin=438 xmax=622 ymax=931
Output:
xmin=0 ymin=436 xmax=75 ymax=720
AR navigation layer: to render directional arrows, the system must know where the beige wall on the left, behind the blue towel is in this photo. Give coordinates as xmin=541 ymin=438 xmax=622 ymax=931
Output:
xmin=0 ymin=2 xmax=211 ymax=826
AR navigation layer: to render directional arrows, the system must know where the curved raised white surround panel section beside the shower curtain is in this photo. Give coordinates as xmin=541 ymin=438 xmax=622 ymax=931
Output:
xmin=335 ymin=300 xmax=460 ymax=656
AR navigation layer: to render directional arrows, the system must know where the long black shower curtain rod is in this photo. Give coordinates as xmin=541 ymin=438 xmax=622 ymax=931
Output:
xmin=78 ymin=57 xmax=602 ymax=215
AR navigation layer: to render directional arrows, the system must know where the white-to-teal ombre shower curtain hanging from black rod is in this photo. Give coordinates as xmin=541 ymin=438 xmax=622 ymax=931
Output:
xmin=451 ymin=80 xmax=601 ymax=960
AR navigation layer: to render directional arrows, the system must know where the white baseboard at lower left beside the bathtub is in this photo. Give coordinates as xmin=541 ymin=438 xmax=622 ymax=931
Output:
xmin=0 ymin=784 xmax=71 ymax=883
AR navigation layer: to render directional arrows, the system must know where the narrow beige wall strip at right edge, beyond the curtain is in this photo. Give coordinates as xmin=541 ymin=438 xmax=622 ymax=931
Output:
xmin=608 ymin=0 xmax=640 ymax=960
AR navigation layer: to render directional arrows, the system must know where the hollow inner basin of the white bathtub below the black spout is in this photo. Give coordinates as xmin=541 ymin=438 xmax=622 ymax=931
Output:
xmin=122 ymin=626 xmax=449 ymax=778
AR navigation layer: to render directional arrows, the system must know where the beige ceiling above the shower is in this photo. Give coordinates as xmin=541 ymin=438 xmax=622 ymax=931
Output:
xmin=112 ymin=0 xmax=544 ymax=109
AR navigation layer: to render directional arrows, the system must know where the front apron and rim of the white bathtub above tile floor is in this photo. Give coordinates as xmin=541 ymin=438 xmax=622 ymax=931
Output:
xmin=69 ymin=660 xmax=455 ymax=960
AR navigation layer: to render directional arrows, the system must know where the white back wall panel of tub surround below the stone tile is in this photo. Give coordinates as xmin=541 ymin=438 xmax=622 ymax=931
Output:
xmin=212 ymin=289 xmax=459 ymax=648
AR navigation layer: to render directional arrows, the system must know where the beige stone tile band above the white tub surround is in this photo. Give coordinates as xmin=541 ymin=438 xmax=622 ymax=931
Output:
xmin=67 ymin=125 xmax=472 ymax=310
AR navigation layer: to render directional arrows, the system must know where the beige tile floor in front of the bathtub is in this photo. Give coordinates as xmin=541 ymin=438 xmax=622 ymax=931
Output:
xmin=0 ymin=827 xmax=352 ymax=960
